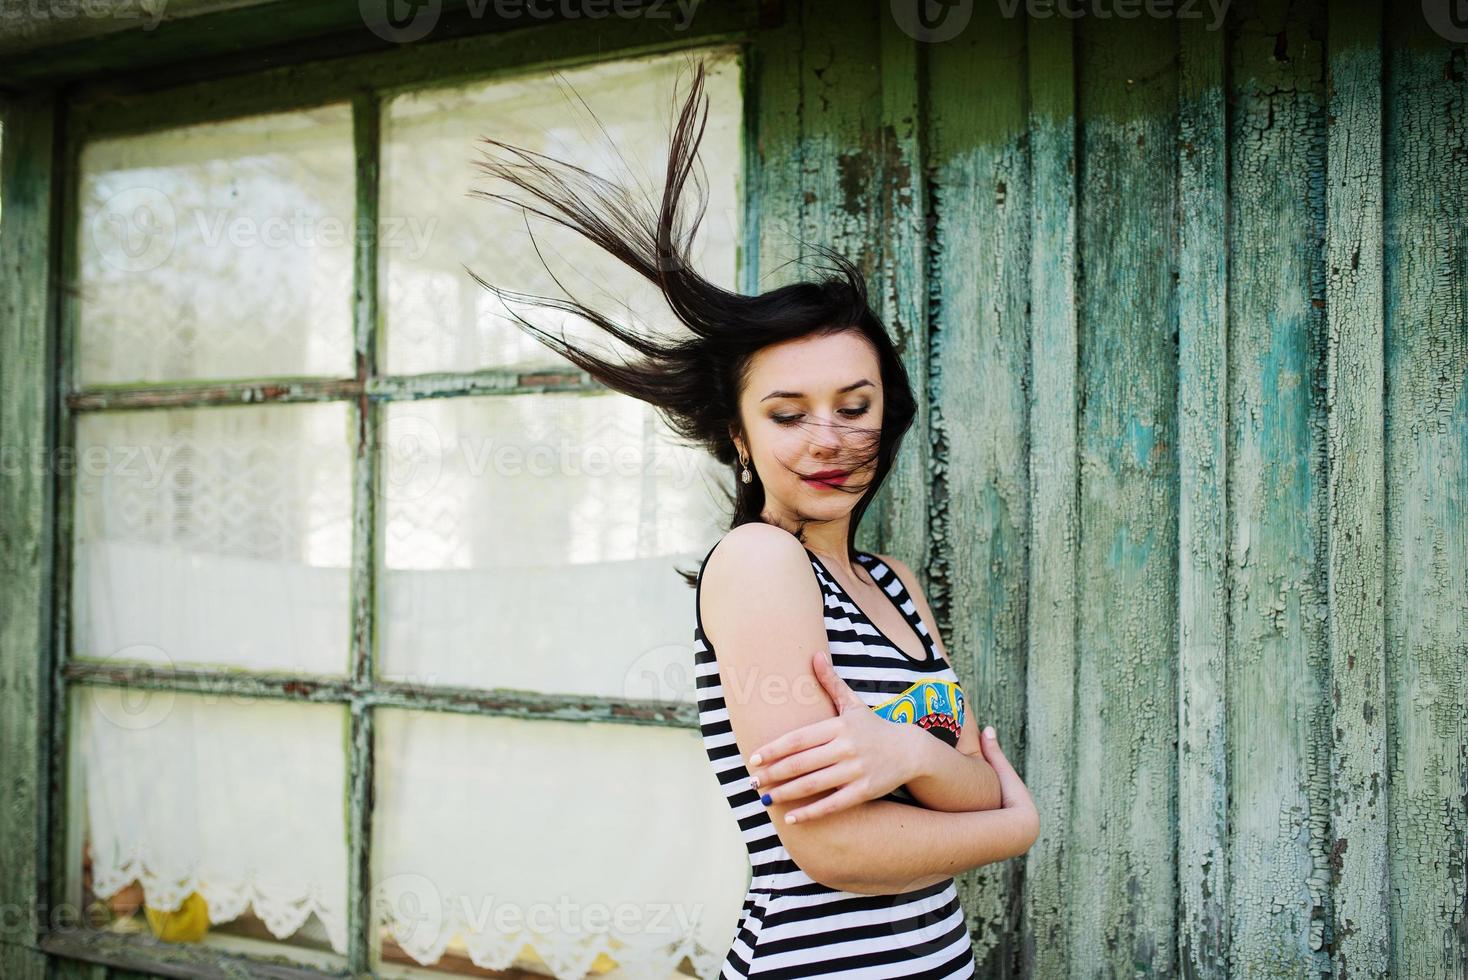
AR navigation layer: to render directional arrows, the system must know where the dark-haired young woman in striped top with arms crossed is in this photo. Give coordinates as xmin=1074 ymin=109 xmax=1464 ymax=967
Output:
xmin=471 ymin=57 xmax=1039 ymax=979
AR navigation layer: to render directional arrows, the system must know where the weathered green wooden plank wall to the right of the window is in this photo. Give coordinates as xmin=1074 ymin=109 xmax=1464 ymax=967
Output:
xmin=757 ymin=0 xmax=1468 ymax=977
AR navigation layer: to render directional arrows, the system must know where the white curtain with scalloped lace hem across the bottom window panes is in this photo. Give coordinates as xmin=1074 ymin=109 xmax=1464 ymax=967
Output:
xmin=73 ymin=685 xmax=747 ymax=979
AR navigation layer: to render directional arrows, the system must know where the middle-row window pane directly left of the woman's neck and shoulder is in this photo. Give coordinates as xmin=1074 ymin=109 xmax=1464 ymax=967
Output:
xmin=379 ymin=392 xmax=731 ymax=703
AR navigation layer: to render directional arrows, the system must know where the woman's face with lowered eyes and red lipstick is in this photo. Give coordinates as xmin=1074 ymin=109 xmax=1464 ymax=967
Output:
xmin=734 ymin=330 xmax=882 ymax=521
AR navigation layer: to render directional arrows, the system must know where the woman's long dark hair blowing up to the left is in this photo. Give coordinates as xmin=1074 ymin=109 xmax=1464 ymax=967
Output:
xmin=465 ymin=60 xmax=918 ymax=585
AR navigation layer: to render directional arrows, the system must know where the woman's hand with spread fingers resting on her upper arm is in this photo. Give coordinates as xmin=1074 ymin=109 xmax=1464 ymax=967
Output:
xmin=749 ymin=651 xmax=916 ymax=823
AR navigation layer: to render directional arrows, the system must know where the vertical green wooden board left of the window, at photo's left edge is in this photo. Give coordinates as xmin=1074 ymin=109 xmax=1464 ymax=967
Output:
xmin=0 ymin=88 xmax=57 ymax=980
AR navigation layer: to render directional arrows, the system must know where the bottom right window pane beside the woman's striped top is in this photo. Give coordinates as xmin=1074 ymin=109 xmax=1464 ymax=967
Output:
xmin=371 ymin=709 xmax=749 ymax=980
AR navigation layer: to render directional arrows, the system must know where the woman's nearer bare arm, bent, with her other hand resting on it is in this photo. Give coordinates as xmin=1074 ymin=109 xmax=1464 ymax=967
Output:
xmin=700 ymin=524 xmax=1038 ymax=895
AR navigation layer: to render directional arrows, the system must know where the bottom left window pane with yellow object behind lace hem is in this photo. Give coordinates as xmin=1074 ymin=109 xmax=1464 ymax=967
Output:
xmin=69 ymin=685 xmax=349 ymax=968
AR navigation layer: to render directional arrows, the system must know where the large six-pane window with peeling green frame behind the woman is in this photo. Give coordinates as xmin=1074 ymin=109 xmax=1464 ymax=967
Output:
xmin=62 ymin=47 xmax=746 ymax=977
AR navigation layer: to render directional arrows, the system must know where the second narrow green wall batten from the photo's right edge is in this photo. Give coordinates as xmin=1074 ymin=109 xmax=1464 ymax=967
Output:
xmin=1177 ymin=9 xmax=1229 ymax=980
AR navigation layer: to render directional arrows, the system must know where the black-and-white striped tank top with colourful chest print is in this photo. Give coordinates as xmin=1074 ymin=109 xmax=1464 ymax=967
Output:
xmin=693 ymin=546 xmax=976 ymax=980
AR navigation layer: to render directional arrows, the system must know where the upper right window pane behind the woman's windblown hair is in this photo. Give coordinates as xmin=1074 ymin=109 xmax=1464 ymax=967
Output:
xmin=379 ymin=50 xmax=743 ymax=374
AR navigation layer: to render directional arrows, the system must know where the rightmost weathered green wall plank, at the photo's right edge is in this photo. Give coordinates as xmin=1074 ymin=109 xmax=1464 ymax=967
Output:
xmin=1384 ymin=9 xmax=1468 ymax=980
